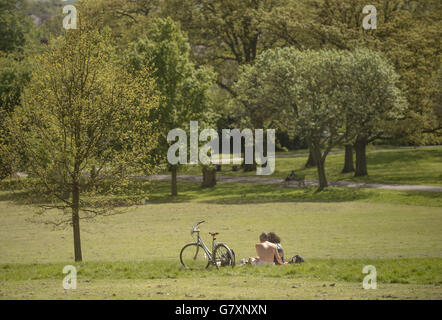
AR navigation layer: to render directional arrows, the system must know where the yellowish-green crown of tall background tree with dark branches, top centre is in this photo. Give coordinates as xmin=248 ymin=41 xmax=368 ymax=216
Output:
xmin=162 ymin=0 xmax=283 ymax=95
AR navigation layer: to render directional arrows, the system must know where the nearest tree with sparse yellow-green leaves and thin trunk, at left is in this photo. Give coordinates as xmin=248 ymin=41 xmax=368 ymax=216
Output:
xmin=1 ymin=19 xmax=159 ymax=261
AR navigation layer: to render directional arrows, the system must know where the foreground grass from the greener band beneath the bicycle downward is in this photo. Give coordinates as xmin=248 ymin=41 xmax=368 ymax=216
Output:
xmin=0 ymin=258 xmax=442 ymax=299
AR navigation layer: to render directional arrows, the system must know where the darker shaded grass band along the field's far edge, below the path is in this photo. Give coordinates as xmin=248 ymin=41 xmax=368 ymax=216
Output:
xmin=0 ymin=181 xmax=442 ymax=207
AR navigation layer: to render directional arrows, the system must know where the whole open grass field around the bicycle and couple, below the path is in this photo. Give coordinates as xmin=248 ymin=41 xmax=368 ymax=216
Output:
xmin=0 ymin=175 xmax=442 ymax=299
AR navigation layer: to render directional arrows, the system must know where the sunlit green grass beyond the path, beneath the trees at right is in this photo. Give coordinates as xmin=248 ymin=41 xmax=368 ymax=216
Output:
xmin=176 ymin=147 xmax=442 ymax=186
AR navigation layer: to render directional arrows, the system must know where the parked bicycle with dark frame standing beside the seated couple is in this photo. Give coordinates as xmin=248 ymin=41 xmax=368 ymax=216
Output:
xmin=180 ymin=221 xmax=235 ymax=269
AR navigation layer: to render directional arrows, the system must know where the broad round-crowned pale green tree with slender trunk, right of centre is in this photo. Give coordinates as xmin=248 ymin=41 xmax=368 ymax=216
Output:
xmin=238 ymin=47 xmax=404 ymax=190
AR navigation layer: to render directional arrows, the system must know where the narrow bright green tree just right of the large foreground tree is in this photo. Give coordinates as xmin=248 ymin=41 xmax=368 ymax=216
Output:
xmin=129 ymin=18 xmax=215 ymax=196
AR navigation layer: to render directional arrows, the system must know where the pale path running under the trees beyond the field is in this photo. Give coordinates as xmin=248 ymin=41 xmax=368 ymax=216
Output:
xmin=149 ymin=174 xmax=442 ymax=192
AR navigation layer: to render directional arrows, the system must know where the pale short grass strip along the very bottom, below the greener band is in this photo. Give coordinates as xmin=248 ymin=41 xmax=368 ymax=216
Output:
xmin=0 ymin=276 xmax=442 ymax=300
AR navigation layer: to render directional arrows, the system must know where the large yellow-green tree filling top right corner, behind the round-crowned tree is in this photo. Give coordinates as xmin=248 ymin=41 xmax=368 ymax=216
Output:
xmin=265 ymin=0 xmax=442 ymax=171
